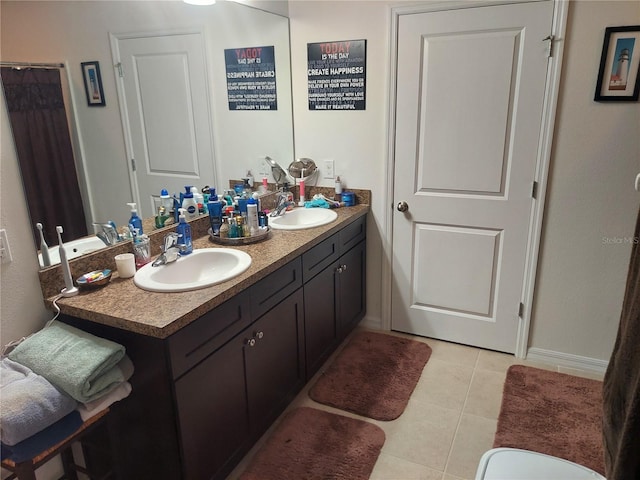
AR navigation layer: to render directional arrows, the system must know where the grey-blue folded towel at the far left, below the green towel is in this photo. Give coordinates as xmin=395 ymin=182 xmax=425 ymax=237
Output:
xmin=0 ymin=358 xmax=77 ymax=446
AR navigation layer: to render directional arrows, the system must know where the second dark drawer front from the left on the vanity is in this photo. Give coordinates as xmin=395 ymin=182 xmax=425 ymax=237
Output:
xmin=251 ymin=257 xmax=302 ymax=319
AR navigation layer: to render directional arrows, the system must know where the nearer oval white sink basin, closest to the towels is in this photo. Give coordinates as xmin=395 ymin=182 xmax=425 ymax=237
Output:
xmin=133 ymin=248 xmax=251 ymax=292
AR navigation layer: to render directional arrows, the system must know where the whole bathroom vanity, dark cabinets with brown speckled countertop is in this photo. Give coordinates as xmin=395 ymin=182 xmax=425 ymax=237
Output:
xmin=48 ymin=205 xmax=369 ymax=480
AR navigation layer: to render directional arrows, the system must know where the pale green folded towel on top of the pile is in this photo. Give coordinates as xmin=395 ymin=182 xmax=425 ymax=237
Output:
xmin=8 ymin=322 xmax=125 ymax=403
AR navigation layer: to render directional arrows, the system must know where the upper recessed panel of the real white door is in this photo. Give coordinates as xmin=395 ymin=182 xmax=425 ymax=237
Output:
xmin=418 ymin=31 xmax=519 ymax=195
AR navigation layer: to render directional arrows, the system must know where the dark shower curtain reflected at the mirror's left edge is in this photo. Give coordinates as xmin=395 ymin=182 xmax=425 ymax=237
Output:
xmin=0 ymin=67 xmax=87 ymax=251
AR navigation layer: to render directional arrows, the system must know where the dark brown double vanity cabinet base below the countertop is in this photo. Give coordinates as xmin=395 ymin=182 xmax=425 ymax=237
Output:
xmin=65 ymin=217 xmax=366 ymax=480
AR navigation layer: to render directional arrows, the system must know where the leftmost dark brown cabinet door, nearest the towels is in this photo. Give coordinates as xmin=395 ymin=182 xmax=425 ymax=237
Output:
xmin=175 ymin=337 xmax=249 ymax=479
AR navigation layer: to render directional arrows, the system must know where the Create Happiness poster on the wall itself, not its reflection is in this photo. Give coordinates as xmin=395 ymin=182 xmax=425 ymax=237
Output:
xmin=307 ymin=40 xmax=367 ymax=110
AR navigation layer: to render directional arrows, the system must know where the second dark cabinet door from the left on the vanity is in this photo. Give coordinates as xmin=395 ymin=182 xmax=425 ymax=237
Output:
xmin=244 ymin=289 xmax=305 ymax=434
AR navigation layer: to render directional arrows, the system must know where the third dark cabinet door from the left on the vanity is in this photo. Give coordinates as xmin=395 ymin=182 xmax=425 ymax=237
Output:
xmin=304 ymin=262 xmax=338 ymax=380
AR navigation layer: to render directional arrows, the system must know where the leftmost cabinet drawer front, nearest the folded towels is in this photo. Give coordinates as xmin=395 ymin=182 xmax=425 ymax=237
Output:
xmin=168 ymin=292 xmax=251 ymax=379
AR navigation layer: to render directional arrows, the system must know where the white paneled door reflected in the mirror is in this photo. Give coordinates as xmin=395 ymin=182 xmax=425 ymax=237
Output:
xmin=113 ymin=33 xmax=216 ymax=217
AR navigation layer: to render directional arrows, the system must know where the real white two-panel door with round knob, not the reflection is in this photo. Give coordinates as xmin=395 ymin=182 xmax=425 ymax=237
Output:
xmin=391 ymin=1 xmax=553 ymax=353
